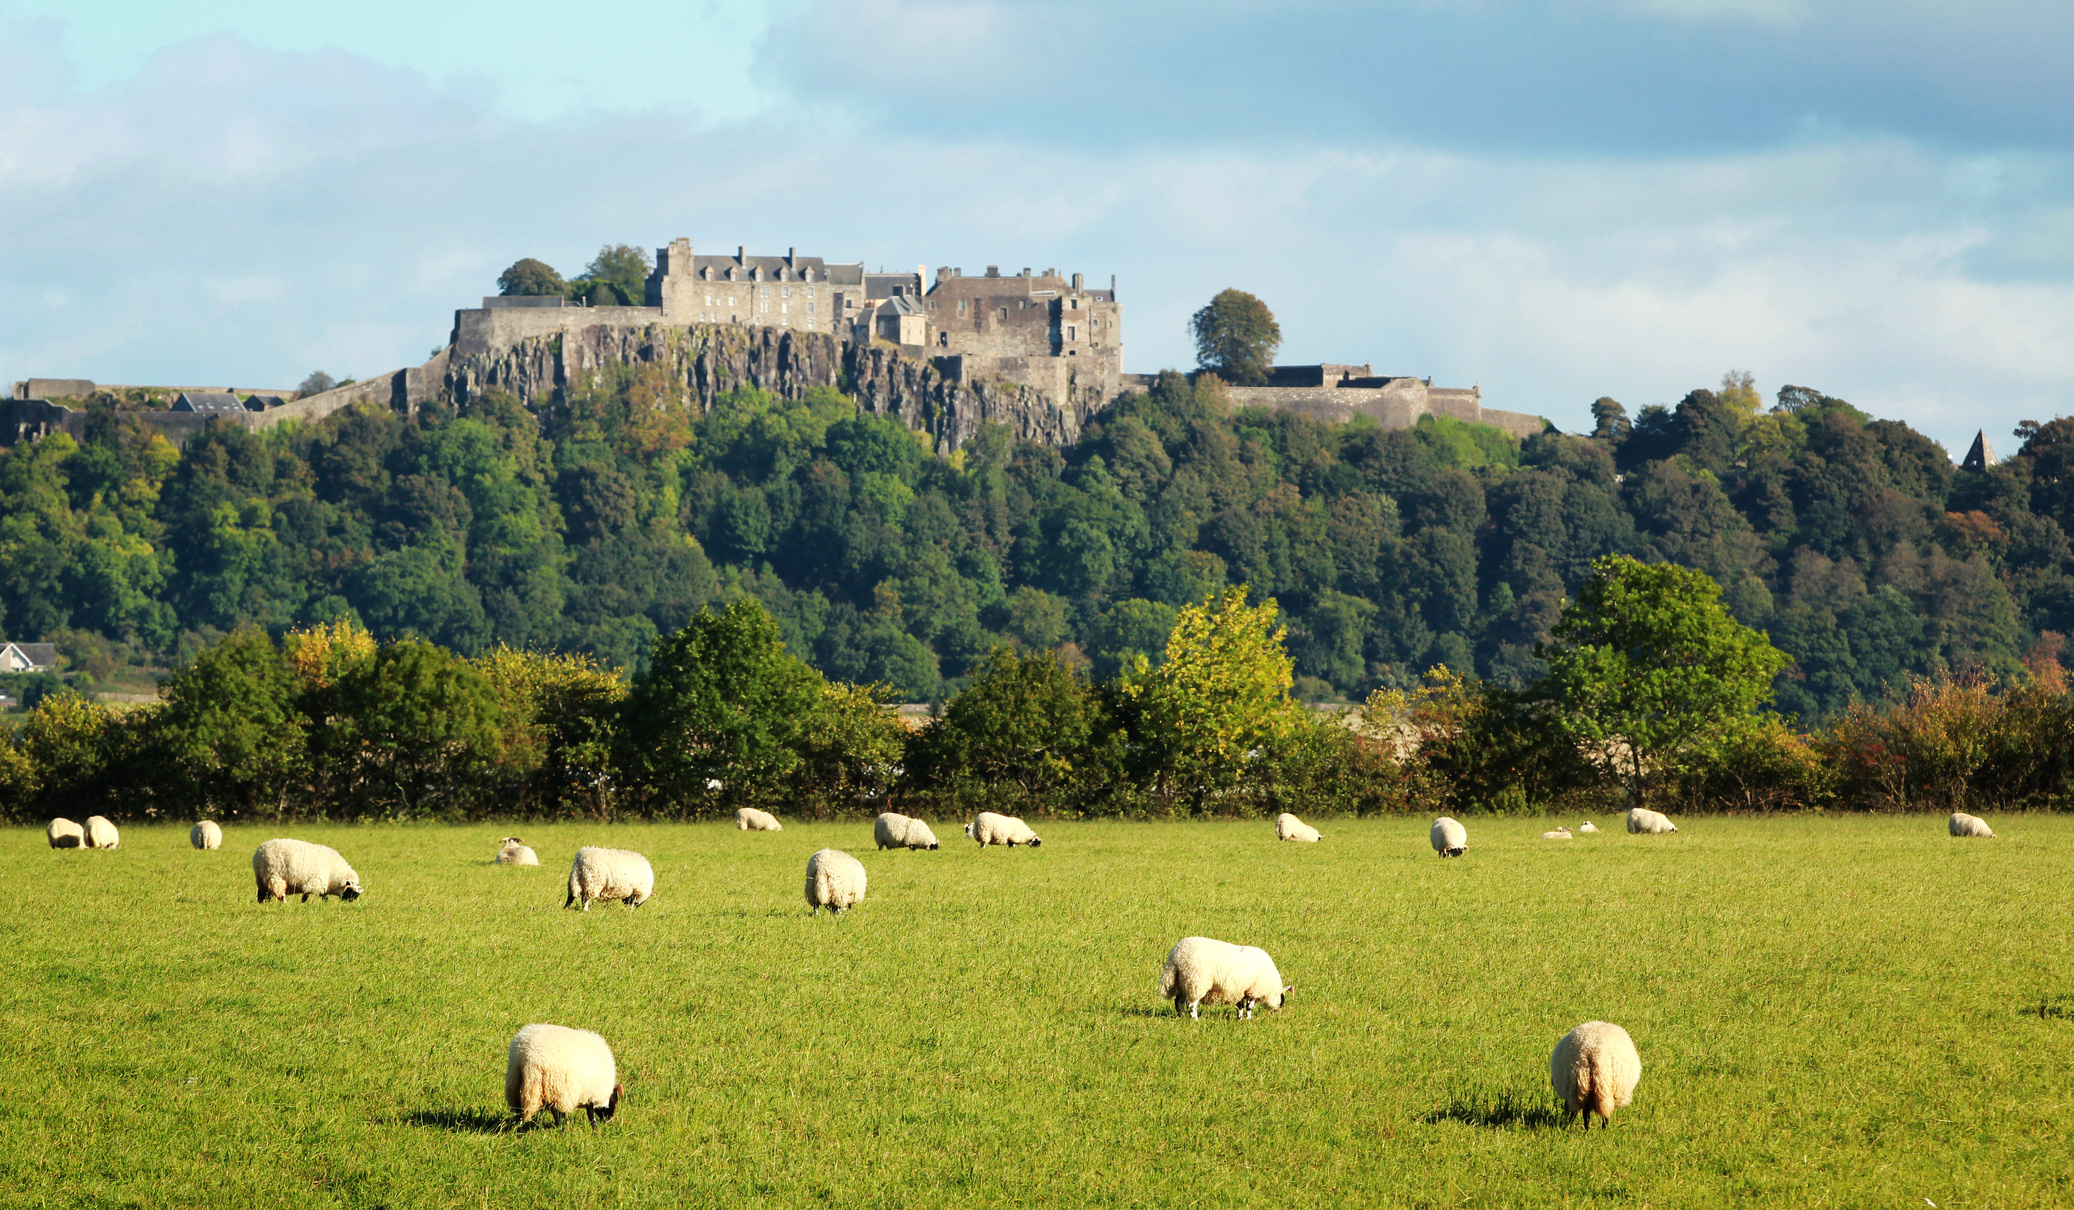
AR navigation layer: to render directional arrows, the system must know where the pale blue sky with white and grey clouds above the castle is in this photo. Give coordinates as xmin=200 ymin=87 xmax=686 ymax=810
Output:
xmin=0 ymin=0 xmax=2074 ymax=457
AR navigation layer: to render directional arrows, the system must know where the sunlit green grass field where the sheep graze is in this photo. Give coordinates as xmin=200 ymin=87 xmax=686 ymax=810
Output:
xmin=0 ymin=816 xmax=2074 ymax=1210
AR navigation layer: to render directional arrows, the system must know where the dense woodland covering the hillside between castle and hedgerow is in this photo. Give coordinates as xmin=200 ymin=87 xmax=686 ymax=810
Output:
xmin=0 ymin=367 xmax=2074 ymax=724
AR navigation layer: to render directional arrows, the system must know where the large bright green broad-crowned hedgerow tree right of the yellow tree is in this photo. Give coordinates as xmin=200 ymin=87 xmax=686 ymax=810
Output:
xmin=1535 ymin=554 xmax=1788 ymax=805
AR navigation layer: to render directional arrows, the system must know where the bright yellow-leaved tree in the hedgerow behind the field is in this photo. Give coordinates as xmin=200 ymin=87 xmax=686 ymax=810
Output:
xmin=1124 ymin=585 xmax=1298 ymax=812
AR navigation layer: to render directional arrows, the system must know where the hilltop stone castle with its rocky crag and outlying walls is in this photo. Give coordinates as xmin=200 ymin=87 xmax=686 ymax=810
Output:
xmin=0 ymin=239 xmax=1545 ymax=448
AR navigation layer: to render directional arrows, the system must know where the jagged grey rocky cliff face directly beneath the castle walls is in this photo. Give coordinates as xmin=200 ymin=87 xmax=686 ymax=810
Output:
xmin=440 ymin=324 xmax=1089 ymax=452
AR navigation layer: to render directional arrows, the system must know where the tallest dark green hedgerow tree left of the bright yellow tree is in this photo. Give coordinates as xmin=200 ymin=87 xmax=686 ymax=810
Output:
xmin=620 ymin=600 xmax=823 ymax=805
